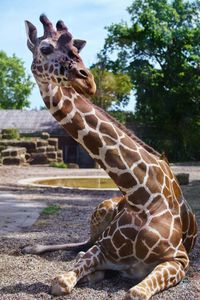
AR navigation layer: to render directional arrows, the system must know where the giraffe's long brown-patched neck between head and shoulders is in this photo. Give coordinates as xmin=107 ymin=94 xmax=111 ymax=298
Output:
xmin=38 ymin=82 xmax=161 ymax=194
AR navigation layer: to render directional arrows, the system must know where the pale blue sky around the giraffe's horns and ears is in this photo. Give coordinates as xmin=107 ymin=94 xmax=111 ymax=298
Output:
xmin=0 ymin=0 xmax=134 ymax=110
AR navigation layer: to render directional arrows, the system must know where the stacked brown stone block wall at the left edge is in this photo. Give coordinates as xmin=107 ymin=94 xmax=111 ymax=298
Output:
xmin=0 ymin=136 xmax=63 ymax=165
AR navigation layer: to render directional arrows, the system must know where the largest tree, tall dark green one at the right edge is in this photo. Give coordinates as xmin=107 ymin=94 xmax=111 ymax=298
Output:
xmin=104 ymin=0 xmax=200 ymax=160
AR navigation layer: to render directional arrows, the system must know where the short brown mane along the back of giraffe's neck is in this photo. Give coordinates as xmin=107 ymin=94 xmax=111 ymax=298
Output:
xmin=93 ymin=104 xmax=161 ymax=159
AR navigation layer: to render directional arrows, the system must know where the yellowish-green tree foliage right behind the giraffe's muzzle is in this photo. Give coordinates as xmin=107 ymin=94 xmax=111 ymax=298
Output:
xmin=90 ymin=54 xmax=132 ymax=110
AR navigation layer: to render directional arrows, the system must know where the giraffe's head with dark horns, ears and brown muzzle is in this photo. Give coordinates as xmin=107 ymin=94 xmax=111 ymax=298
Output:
xmin=25 ymin=15 xmax=96 ymax=95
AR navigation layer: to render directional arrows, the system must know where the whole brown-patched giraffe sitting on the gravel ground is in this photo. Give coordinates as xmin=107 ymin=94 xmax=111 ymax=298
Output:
xmin=23 ymin=15 xmax=197 ymax=300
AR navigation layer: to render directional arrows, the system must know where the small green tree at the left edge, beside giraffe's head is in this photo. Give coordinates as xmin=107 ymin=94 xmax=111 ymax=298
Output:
xmin=0 ymin=51 xmax=34 ymax=109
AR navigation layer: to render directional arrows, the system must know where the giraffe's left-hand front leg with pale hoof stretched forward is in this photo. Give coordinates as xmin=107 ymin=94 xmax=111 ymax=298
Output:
xmin=51 ymin=245 xmax=104 ymax=296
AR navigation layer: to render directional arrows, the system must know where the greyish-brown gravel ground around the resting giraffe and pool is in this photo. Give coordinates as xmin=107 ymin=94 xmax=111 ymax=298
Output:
xmin=0 ymin=166 xmax=200 ymax=300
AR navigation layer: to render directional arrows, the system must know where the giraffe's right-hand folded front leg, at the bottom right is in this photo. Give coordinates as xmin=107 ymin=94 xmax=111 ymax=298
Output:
xmin=124 ymin=257 xmax=189 ymax=300
